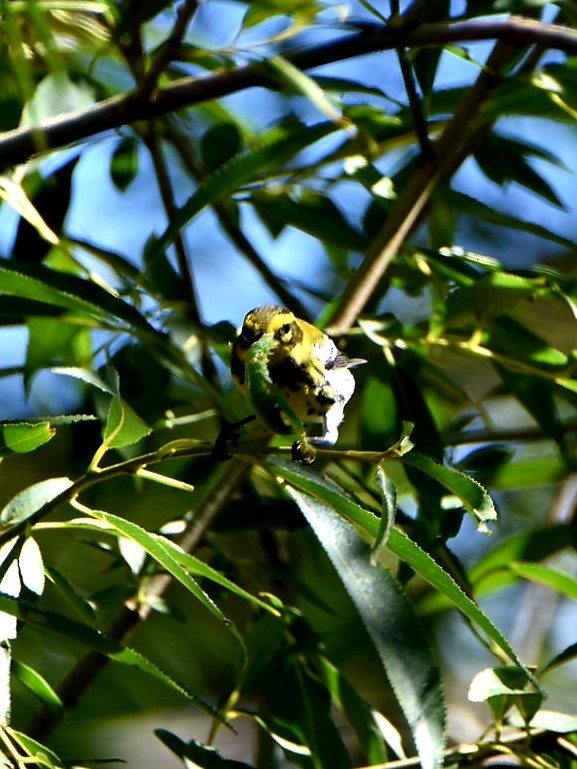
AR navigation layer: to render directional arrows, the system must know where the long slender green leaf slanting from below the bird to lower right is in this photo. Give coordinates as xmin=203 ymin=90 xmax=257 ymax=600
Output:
xmin=271 ymin=460 xmax=538 ymax=685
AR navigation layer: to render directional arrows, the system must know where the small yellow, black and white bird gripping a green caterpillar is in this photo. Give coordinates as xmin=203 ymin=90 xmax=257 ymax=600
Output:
xmin=231 ymin=305 xmax=355 ymax=443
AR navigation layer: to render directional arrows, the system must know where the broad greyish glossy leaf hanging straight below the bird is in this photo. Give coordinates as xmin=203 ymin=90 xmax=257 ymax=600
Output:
xmin=289 ymin=488 xmax=445 ymax=769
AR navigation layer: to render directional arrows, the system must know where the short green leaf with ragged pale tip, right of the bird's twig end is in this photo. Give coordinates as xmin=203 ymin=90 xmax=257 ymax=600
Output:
xmin=400 ymin=451 xmax=497 ymax=533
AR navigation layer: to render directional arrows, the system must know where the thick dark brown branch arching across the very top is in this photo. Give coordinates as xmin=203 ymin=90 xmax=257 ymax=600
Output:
xmin=0 ymin=17 xmax=577 ymax=167
